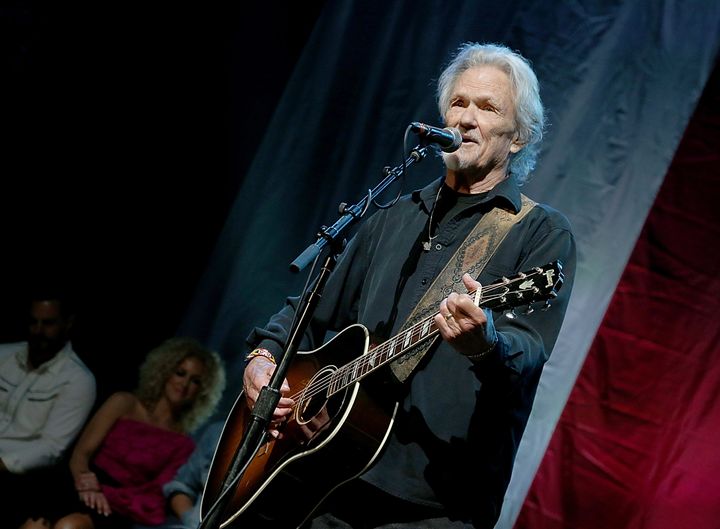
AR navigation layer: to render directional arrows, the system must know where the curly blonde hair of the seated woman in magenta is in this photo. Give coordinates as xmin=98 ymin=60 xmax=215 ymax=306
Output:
xmin=135 ymin=336 xmax=225 ymax=433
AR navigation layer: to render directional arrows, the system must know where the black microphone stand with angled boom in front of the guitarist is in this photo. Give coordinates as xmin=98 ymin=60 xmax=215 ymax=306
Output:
xmin=198 ymin=145 xmax=427 ymax=529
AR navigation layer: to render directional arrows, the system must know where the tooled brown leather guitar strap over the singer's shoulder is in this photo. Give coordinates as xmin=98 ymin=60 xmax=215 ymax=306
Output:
xmin=390 ymin=195 xmax=536 ymax=382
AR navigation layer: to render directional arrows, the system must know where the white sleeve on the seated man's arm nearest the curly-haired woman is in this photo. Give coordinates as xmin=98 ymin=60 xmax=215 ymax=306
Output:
xmin=3 ymin=366 xmax=95 ymax=474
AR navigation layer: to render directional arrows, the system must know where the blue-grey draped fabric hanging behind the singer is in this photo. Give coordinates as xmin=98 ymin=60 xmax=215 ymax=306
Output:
xmin=179 ymin=0 xmax=720 ymax=528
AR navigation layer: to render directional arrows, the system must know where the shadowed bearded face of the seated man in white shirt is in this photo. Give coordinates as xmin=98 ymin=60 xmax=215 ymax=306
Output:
xmin=28 ymin=300 xmax=71 ymax=357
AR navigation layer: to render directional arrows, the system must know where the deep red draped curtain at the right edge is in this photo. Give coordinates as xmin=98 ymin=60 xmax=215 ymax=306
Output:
xmin=515 ymin=60 xmax=720 ymax=529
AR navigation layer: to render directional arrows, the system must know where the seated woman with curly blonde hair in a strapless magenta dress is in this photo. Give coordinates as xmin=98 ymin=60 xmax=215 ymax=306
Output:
xmin=53 ymin=337 xmax=225 ymax=529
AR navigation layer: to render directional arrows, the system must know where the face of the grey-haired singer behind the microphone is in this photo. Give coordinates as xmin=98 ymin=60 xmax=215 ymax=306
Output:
xmin=443 ymin=65 xmax=522 ymax=178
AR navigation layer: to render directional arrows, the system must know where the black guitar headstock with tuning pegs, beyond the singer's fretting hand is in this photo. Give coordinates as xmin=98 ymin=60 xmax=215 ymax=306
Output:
xmin=479 ymin=260 xmax=564 ymax=313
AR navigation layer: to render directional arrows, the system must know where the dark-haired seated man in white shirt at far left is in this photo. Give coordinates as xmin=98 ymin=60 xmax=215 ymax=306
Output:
xmin=0 ymin=292 xmax=95 ymax=528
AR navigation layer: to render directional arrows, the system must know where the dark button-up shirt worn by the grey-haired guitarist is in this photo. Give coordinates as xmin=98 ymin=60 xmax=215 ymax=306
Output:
xmin=248 ymin=174 xmax=575 ymax=527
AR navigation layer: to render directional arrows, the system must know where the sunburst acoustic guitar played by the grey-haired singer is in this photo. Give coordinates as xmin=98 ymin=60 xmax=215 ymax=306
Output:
xmin=200 ymin=261 xmax=563 ymax=529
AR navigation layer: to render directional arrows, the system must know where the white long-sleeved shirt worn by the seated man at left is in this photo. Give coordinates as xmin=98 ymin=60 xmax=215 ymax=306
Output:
xmin=0 ymin=342 xmax=95 ymax=474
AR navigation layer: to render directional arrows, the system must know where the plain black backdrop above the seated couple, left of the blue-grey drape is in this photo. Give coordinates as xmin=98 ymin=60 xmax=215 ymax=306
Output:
xmin=0 ymin=0 xmax=323 ymax=399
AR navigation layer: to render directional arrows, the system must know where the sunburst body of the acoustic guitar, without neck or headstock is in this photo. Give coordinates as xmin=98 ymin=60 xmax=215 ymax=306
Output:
xmin=201 ymin=324 xmax=397 ymax=529
